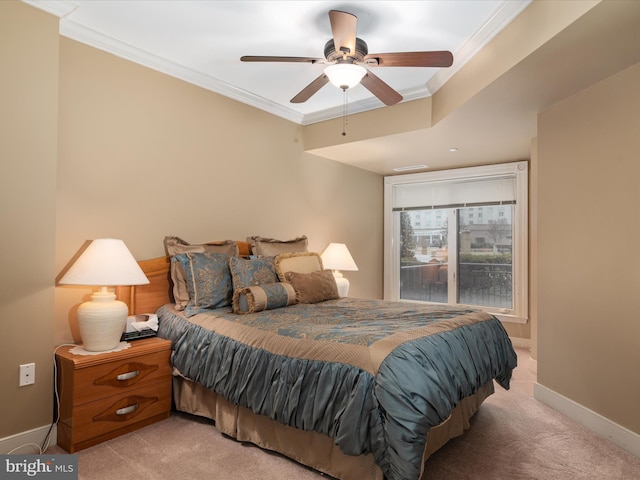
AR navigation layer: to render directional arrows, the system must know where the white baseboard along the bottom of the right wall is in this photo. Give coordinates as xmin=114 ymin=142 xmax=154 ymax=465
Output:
xmin=533 ymin=383 xmax=640 ymax=458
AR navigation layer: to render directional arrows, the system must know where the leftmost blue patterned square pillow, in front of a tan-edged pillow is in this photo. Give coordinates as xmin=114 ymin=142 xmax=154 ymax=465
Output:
xmin=171 ymin=252 xmax=233 ymax=317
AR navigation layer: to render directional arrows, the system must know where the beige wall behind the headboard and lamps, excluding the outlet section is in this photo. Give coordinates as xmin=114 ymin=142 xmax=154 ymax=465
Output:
xmin=55 ymin=38 xmax=382 ymax=343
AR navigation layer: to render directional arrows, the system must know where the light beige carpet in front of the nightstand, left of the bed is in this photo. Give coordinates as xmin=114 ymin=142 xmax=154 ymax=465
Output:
xmin=59 ymin=413 xmax=322 ymax=480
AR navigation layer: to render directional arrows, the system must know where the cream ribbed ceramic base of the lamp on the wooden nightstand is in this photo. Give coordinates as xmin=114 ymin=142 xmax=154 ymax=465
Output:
xmin=78 ymin=287 xmax=129 ymax=352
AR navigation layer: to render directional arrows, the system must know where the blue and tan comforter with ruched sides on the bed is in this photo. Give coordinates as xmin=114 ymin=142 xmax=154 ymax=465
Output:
xmin=158 ymin=298 xmax=517 ymax=480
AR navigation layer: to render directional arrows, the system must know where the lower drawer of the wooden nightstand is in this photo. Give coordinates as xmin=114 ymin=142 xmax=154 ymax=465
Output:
xmin=70 ymin=382 xmax=171 ymax=445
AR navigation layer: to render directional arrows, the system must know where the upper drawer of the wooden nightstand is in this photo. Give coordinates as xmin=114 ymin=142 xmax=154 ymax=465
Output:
xmin=69 ymin=350 xmax=171 ymax=405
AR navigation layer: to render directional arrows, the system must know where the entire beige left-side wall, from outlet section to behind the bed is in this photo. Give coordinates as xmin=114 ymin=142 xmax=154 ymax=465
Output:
xmin=0 ymin=2 xmax=382 ymax=446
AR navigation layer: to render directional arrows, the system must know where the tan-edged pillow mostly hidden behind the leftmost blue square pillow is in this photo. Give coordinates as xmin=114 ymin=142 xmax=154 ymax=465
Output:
xmin=164 ymin=237 xmax=238 ymax=310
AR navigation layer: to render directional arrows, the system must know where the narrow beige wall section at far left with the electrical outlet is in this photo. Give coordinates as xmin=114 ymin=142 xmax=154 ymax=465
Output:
xmin=0 ymin=2 xmax=58 ymax=438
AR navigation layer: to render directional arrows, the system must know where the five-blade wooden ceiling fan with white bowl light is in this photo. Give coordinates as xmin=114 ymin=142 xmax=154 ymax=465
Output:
xmin=240 ymin=10 xmax=453 ymax=105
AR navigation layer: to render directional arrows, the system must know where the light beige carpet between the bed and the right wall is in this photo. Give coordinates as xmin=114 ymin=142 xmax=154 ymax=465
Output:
xmin=423 ymin=349 xmax=640 ymax=480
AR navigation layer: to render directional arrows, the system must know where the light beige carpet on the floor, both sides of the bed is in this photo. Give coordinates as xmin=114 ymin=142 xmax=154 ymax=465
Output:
xmin=48 ymin=350 xmax=640 ymax=480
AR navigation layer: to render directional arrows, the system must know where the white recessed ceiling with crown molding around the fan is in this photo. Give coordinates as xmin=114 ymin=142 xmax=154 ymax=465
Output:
xmin=30 ymin=0 xmax=530 ymax=125
